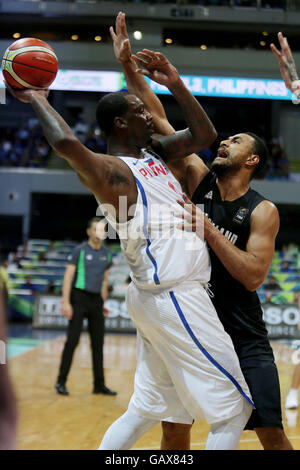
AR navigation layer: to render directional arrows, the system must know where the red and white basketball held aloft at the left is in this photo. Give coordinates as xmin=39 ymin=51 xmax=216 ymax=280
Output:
xmin=2 ymin=38 xmax=58 ymax=90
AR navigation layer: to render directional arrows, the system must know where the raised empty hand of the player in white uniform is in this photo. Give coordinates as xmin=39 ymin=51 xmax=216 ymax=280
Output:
xmin=132 ymin=49 xmax=179 ymax=88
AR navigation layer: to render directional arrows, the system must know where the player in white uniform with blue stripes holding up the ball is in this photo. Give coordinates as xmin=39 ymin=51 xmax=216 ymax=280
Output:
xmin=4 ymin=35 xmax=253 ymax=450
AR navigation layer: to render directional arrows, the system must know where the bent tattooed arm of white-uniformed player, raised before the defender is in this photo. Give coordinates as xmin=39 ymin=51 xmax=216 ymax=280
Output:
xmin=133 ymin=49 xmax=217 ymax=161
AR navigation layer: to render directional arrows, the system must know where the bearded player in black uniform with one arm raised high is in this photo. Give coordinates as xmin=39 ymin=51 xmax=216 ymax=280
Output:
xmin=112 ymin=13 xmax=292 ymax=449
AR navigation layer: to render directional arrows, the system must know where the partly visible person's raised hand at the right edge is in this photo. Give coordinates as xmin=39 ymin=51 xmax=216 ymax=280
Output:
xmin=270 ymin=33 xmax=300 ymax=92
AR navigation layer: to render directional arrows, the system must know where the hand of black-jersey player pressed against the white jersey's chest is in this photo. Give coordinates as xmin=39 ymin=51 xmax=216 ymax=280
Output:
xmin=175 ymin=194 xmax=210 ymax=239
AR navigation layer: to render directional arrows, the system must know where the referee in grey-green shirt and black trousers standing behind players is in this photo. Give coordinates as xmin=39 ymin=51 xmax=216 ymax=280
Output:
xmin=55 ymin=217 xmax=116 ymax=395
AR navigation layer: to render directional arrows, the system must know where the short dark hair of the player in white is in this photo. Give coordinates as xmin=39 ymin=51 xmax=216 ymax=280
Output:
xmin=96 ymin=91 xmax=129 ymax=137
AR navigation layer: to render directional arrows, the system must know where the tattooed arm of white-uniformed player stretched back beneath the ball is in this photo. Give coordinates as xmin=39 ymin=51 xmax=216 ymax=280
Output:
xmin=6 ymin=83 xmax=137 ymax=217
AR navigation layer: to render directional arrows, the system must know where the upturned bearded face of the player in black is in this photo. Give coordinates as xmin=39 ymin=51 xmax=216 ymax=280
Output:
xmin=212 ymin=134 xmax=254 ymax=174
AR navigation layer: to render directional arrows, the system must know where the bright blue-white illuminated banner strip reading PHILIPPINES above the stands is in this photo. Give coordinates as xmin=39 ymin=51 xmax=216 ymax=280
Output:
xmin=0 ymin=70 xmax=293 ymax=100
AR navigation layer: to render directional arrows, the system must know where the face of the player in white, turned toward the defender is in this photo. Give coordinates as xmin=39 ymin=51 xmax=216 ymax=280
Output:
xmin=126 ymin=95 xmax=154 ymax=146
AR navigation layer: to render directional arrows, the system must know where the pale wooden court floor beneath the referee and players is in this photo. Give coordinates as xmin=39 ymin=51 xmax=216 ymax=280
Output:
xmin=9 ymin=333 xmax=300 ymax=450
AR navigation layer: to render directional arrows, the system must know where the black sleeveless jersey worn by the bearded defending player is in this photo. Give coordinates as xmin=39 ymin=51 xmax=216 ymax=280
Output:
xmin=192 ymin=172 xmax=270 ymax=359
